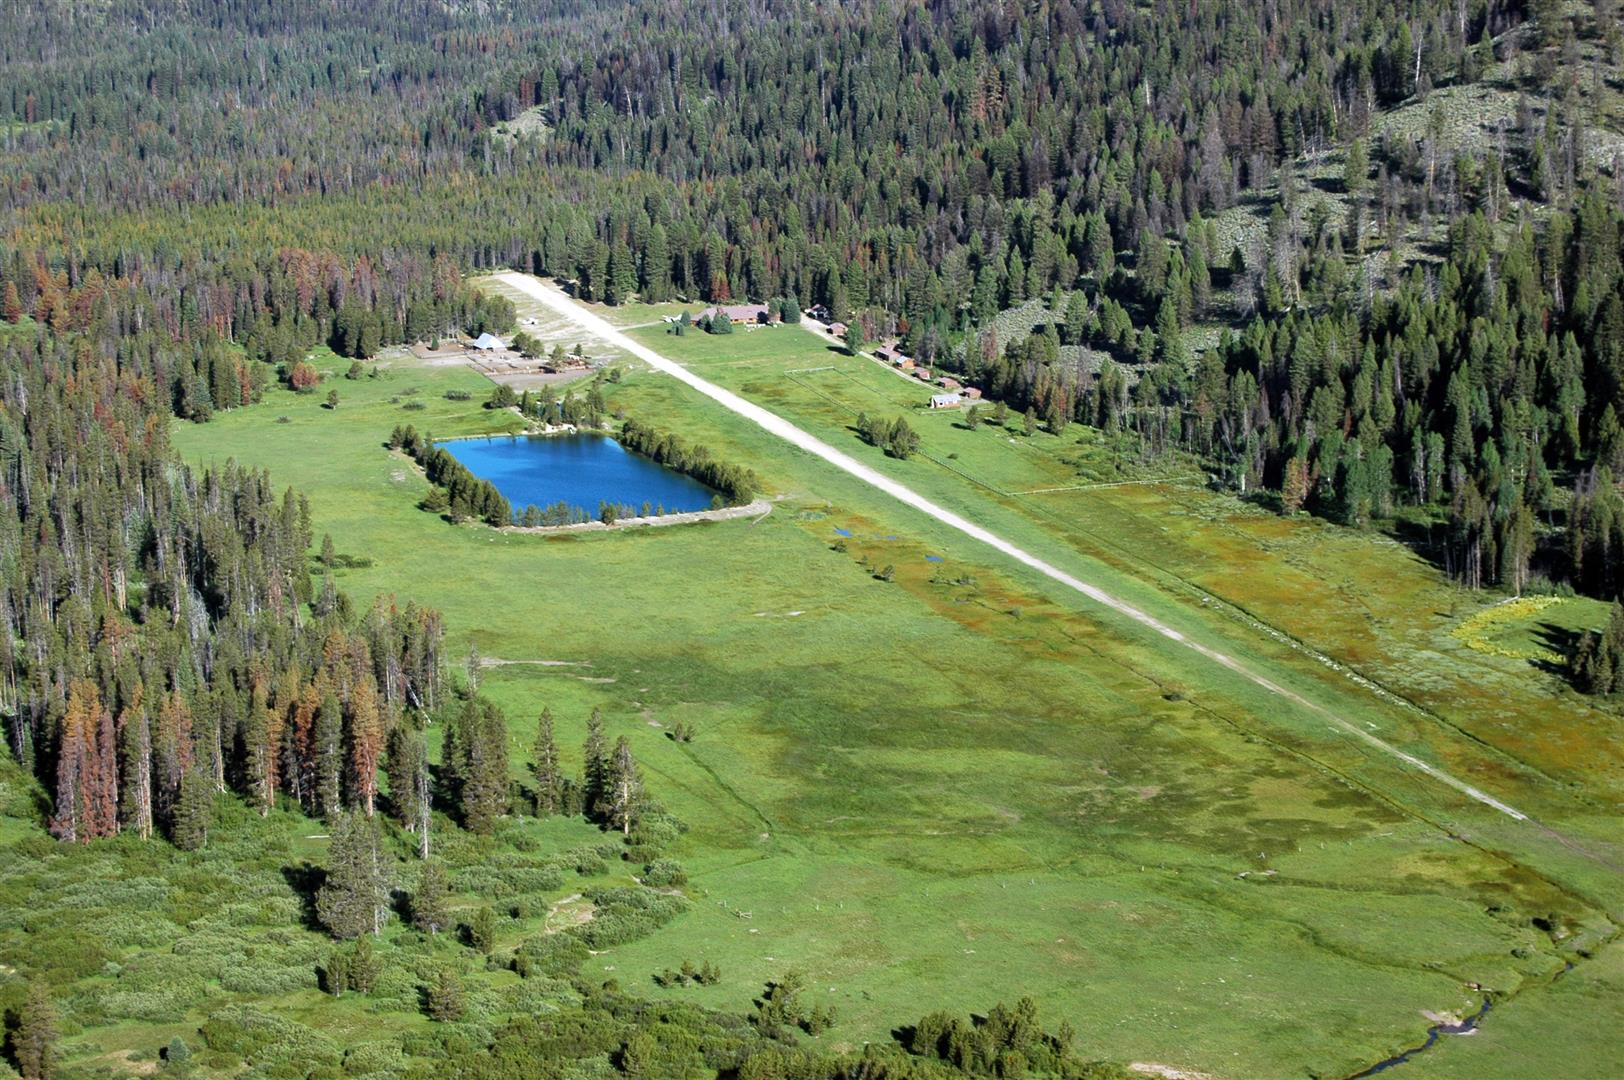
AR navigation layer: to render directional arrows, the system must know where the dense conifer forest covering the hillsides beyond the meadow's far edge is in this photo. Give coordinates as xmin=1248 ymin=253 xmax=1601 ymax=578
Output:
xmin=0 ymin=3 xmax=1624 ymax=596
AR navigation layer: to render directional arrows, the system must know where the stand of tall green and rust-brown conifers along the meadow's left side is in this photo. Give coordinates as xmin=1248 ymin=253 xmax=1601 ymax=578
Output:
xmin=0 ymin=332 xmax=443 ymax=846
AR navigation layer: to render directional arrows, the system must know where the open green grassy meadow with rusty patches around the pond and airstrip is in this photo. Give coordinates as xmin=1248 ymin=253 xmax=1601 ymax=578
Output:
xmin=155 ymin=297 xmax=1624 ymax=1077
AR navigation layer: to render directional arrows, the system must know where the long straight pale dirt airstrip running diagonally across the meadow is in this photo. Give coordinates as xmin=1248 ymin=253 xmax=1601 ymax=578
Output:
xmin=497 ymin=273 xmax=1528 ymax=822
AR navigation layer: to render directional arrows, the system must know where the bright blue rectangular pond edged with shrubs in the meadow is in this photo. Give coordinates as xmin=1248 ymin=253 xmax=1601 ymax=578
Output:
xmin=442 ymin=435 xmax=716 ymax=513
